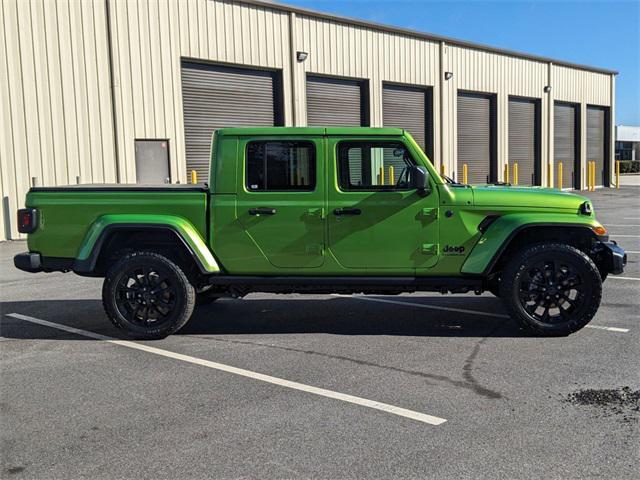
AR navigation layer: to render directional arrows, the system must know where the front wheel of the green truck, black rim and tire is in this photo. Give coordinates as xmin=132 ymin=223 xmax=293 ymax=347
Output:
xmin=500 ymin=243 xmax=602 ymax=336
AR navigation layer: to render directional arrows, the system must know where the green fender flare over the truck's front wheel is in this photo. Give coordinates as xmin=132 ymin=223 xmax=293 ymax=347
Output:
xmin=461 ymin=213 xmax=603 ymax=275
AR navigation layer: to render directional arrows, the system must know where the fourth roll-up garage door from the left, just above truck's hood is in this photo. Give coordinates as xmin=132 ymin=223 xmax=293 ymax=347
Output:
xmin=456 ymin=93 xmax=495 ymax=183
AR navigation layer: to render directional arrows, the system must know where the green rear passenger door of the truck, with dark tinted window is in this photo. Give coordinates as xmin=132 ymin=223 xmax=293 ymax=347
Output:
xmin=237 ymin=136 xmax=325 ymax=272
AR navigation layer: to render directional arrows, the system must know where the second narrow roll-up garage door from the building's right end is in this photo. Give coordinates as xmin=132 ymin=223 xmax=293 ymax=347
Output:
xmin=553 ymin=103 xmax=579 ymax=188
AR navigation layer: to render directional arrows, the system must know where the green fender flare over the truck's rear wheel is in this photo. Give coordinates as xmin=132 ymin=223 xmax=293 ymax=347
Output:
xmin=73 ymin=214 xmax=220 ymax=274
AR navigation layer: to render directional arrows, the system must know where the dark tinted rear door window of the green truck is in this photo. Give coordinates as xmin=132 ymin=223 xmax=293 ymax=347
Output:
xmin=245 ymin=140 xmax=316 ymax=192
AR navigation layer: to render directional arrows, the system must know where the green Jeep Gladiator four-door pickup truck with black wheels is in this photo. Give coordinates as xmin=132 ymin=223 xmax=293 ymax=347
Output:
xmin=14 ymin=127 xmax=626 ymax=338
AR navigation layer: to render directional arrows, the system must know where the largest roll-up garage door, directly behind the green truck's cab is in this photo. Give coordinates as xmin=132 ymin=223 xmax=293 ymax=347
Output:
xmin=182 ymin=62 xmax=281 ymax=183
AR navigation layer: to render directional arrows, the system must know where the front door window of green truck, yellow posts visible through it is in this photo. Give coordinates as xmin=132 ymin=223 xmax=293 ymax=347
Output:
xmin=337 ymin=141 xmax=415 ymax=191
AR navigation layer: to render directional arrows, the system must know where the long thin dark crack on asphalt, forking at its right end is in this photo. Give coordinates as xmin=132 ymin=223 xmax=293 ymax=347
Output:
xmin=184 ymin=335 xmax=502 ymax=399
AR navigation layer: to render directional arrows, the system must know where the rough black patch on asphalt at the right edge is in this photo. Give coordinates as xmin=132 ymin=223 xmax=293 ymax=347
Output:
xmin=567 ymin=387 xmax=640 ymax=422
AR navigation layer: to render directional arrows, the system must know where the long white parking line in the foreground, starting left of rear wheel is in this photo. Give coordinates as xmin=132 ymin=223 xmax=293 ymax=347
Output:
xmin=7 ymin=313 xmax=447 ymax=425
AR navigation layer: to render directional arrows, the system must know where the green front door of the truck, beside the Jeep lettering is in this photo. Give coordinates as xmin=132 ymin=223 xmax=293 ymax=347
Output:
xmin=327 ymin=137 xmax=438 ymax=274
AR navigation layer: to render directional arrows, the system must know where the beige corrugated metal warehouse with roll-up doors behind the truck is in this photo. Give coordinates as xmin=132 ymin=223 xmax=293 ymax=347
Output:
xmin=0 ymin=0 xmax=616 ymax=239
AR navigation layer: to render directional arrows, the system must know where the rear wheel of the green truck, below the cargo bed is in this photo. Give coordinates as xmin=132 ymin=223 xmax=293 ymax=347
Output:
xmin=102 ymin=251 xmax=196 ymax=339
